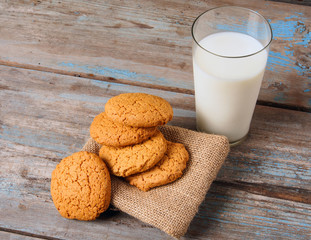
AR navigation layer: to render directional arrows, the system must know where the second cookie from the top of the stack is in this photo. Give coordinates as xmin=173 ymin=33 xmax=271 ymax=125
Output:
xmin=90 ymin=112 xmax=157 ymax=147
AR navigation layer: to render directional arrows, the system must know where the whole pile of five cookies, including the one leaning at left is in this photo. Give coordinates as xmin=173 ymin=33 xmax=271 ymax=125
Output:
xmin=51 ymin=93 xmax=189 ymax=220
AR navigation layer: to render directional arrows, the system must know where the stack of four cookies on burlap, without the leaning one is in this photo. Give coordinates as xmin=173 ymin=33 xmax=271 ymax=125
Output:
xmin=90 ymin=93 xmax=189 ymax=191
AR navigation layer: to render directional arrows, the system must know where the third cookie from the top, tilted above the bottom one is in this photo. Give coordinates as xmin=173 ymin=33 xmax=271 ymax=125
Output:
xmin=99 ymin=130 xmax=167 ymax=177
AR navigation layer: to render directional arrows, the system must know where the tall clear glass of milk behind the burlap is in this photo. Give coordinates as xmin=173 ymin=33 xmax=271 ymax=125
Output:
xmin=192 ymin=6 xmax=272 ymax=145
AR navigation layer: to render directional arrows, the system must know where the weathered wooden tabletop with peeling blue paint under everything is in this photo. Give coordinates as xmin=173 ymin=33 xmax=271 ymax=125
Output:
xmin=0 ymin=0 xmax=311 ymax=240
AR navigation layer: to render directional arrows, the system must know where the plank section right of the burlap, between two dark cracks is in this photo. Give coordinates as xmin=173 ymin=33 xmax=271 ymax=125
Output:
xmin=219 ymin=106 xmax=311 ymax=192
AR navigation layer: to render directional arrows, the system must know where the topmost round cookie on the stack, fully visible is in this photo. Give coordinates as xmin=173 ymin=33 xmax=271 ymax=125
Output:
xmin=105 ymin=93 xmax=173 ymax=127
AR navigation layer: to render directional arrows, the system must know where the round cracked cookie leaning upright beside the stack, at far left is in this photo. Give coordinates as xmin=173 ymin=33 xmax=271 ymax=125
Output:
xmin=51 ymin=151 xmax=111 ymax=220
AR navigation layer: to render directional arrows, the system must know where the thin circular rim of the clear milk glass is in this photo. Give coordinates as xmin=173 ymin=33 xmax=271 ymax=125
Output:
xmin=191 ymin=6 xmax=273 ymax=58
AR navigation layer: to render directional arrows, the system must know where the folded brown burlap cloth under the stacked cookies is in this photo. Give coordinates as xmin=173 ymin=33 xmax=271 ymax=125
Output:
xmin=82 ymin=126 xmax=229 ymax=238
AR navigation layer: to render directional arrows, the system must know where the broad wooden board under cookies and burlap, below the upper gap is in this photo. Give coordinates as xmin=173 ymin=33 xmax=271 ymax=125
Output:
xmin=0 ymin=66 xmax=311 ymax=239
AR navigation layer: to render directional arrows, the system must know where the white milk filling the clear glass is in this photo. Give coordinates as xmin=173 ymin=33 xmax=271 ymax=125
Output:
xmin=193 ymin=32 xmax=268 ymax=142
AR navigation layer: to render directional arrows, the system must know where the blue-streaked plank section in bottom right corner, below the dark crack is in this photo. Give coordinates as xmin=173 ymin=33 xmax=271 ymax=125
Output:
xmin=186 ymin=184 xmax=311 ymax=239
